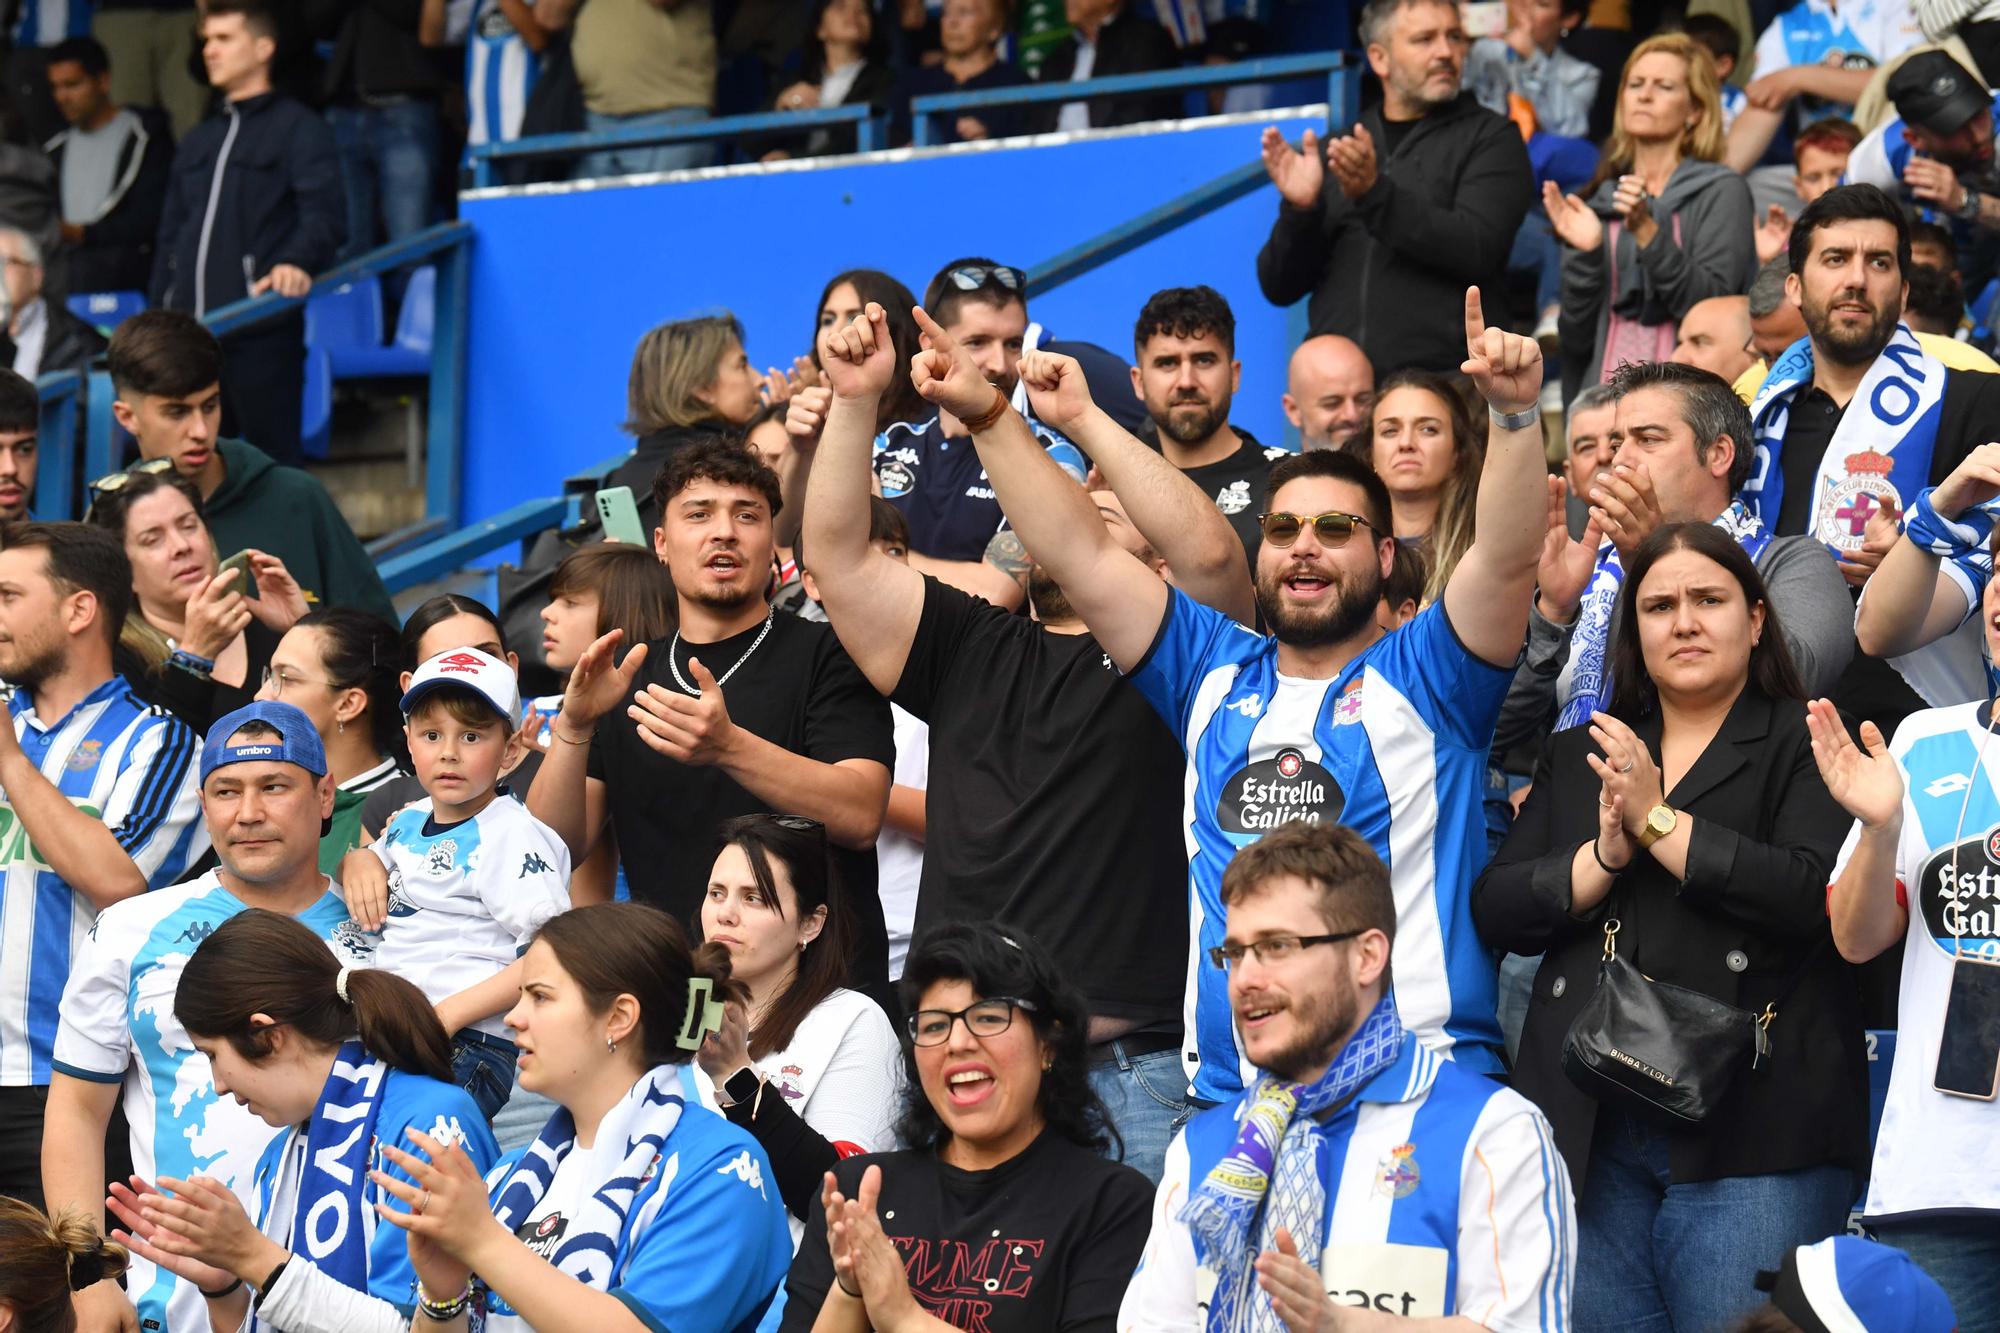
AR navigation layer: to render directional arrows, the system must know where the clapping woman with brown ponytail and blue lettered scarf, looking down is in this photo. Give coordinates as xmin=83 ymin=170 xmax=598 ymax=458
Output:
xmin=110 ymin=909 xmax=500 ymax=1333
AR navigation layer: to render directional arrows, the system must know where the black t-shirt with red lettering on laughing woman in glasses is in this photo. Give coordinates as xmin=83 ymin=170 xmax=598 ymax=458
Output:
xmin=778 ymin=1131 xmax=1152 ymax=1333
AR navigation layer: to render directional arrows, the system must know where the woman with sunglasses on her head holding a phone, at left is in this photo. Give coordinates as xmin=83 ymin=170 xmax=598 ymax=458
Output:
xmin=84 ymin=462 xmax=306 ymax=733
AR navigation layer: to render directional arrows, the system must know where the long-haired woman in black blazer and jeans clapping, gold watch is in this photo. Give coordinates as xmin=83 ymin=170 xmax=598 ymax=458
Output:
xmin=1472 ymin=522 xmax=1868 ymax=1329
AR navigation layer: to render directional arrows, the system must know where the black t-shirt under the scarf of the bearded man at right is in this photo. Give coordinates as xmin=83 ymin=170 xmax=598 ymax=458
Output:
xmin=1776 ymin=368 xmax=2000 ymax=737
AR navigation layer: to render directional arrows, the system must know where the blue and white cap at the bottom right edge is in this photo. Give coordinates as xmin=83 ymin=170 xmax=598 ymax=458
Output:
xmin=1756 ymin=1235 xmax=1958 ymax=1333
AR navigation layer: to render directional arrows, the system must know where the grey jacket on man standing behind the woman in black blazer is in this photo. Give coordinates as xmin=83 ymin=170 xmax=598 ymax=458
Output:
xmin=1492 ymin=536 xmax=1854 ymax=757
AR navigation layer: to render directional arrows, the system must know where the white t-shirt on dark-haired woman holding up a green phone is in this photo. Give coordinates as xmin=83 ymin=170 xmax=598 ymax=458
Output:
xmin=752 ymin=991 xmax=902 ymax=1249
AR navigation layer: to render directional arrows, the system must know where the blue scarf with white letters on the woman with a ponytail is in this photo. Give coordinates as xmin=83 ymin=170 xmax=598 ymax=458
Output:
xmin=260 ymin=1041 xmax=388 ymax=1291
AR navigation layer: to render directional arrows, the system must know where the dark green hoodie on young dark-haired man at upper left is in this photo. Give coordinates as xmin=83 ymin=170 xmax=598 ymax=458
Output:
xmin=202 ymin=440 xmax=402 ymax=624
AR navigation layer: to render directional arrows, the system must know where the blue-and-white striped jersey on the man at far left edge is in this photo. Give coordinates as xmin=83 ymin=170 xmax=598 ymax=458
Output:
xmin=0 ymin=677 xmax=208 ymax=1087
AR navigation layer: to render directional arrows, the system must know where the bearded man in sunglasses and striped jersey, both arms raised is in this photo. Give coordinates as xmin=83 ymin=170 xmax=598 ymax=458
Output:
xmin=914 ymin=288 xmax=1548 ymax=1103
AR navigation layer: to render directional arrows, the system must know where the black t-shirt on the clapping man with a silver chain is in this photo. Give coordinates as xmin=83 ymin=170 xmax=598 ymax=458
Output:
xmin=590 ymin=616 xmax=896 ymax=995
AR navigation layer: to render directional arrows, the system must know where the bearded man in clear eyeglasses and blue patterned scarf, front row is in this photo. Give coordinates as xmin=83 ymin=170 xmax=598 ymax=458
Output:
xmin=1118 ymin=823 xmax=1576 ymax=1333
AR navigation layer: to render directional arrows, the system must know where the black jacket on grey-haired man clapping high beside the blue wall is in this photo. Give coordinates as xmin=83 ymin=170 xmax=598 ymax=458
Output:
xmin=1256 ymin=92 xmax=1534 ymax=376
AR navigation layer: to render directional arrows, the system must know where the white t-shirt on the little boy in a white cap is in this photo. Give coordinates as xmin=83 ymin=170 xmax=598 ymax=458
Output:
xmin=368 ymin=797 xmax=570 ymax=1039
